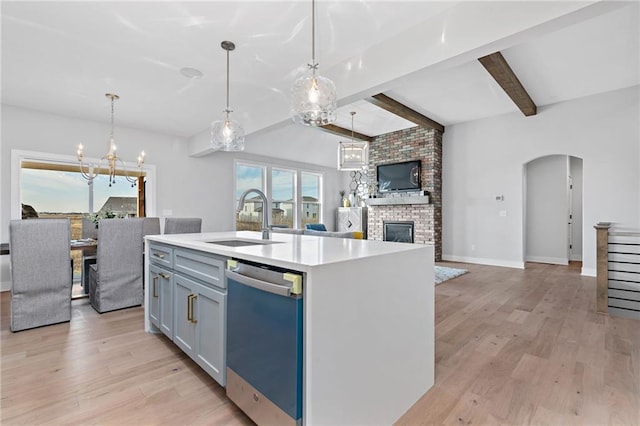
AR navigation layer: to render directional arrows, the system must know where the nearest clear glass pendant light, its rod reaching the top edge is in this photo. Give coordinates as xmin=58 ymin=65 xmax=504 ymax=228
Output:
xmin=291 ymin=0 xmax=338 ymax=126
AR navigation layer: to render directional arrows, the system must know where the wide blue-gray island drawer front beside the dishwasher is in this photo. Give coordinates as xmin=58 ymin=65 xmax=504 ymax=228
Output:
xmin=173 ymin=248 xmax=227 ymax=288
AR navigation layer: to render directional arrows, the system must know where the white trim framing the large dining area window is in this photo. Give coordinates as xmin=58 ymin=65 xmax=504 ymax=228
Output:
xmin=11 ymin=149 xmax=157 ymax=219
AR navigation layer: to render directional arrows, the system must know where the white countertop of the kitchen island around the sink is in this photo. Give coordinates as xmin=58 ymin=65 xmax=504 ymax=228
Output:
xmin=146 ymin=231 xmax=431 ymax=271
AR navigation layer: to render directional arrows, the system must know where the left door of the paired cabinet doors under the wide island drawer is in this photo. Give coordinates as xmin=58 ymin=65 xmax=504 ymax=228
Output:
xmin=173 ymin=274 xmax=197 ymax=358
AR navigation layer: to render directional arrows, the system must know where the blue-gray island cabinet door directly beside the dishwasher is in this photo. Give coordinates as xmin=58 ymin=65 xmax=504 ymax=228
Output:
xmin=194 ymin=284 xmax=227 ymax=386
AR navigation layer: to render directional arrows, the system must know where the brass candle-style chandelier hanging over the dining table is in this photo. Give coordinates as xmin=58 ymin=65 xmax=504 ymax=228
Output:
xmin=78 ymin=93 xmax=145 ymax=187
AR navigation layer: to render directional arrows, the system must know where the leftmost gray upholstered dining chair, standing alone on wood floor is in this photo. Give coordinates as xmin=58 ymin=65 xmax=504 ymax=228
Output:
xmin=9 ymin=219 xmax=72 ymax=331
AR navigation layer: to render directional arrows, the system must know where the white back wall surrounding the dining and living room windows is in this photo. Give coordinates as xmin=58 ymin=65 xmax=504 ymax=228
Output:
xmin=0 ymin=105 xmax=348 ymax=289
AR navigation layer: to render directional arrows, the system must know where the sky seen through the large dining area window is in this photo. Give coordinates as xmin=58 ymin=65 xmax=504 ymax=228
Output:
xmin=20 ymin=169 xmax=138 ymax=213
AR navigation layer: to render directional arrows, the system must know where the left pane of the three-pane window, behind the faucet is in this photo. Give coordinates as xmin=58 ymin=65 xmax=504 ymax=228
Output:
xmin=234 ymin=163 xmax=265 ymax=231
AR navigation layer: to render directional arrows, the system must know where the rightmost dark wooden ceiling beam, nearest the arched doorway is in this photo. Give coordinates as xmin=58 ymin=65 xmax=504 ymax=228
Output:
xmin=478 ymin=52 xmax=538 ymax=117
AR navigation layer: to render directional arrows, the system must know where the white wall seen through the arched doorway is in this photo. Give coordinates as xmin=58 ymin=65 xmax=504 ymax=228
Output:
xmin=525 ymin=155 xmax=569 ymax=265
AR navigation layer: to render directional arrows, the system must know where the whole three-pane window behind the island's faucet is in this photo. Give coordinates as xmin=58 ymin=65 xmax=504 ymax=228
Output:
xmin=236 ymin=162 xmax=322 ymax=231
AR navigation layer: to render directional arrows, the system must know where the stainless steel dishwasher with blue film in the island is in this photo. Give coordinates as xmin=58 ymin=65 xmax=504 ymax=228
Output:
xmin=225 ymin=260 xmax=303 ymax=425
